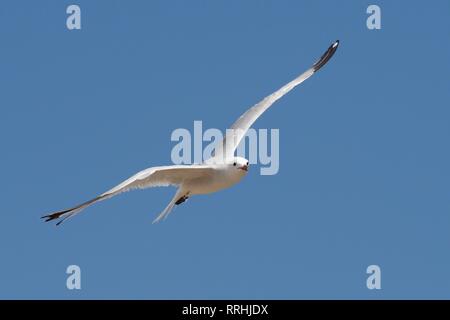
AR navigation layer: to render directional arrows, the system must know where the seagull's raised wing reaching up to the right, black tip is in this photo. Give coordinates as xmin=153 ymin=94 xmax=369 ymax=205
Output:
xmin=210 ymin=40 xmax=339 ymax=162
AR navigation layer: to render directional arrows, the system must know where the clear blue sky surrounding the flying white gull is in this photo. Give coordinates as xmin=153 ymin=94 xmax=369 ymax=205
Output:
xmin=0 ymin=0 xmax=450 ymax=299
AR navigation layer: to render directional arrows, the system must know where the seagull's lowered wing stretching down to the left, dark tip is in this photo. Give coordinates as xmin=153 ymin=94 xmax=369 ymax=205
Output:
xmin=42 ymin=165 xmax=213 ymax=225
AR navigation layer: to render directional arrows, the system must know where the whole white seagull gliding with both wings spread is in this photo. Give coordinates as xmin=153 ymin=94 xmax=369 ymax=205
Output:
xmin=42 ymin=40 xmax=339 ymax=225
